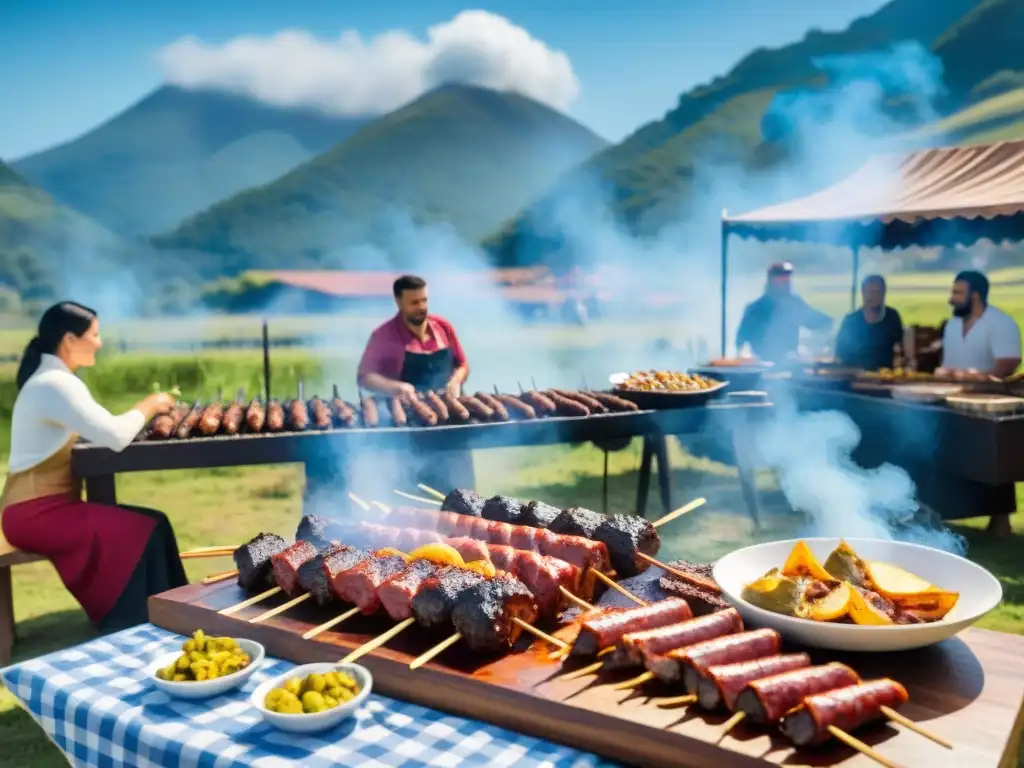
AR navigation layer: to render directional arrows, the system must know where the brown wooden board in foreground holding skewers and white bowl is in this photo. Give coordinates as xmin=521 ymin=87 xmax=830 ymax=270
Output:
xmin=150 ymin=583 xmax=1024 ymax=768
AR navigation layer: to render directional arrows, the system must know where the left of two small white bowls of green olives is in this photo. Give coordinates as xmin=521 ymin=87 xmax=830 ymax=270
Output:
xmin=147 ymin=630 xmax=266 ymax=698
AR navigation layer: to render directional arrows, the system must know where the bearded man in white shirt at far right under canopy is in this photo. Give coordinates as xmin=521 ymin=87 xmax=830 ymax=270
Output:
xmin=942 ymin=270 xmax=1021 ymax=378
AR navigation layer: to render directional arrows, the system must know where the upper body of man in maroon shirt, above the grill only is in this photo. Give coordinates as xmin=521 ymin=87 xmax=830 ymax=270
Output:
xmin=358 ymin=274 xmax=469 ymax=397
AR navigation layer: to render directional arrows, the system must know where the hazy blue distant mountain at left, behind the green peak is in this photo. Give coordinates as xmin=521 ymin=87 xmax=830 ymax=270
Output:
xmin=14 ymin=86 xmax=366 ymax=234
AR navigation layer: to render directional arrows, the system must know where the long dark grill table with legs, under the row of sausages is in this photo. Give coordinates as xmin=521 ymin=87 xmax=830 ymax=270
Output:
xmin=72 ymin=398 xmax=773 ymax=518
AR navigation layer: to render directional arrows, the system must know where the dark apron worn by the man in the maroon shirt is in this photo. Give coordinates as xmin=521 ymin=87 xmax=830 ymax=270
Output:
xmin=398 ymin=347 xmax=475 ymax=494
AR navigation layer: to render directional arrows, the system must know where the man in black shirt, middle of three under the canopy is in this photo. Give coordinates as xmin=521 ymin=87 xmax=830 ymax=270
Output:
xmin=836 ymin=274 xmax=903 ymax=371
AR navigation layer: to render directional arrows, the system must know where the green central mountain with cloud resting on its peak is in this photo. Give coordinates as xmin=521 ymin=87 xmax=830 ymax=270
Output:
xmin=153 ymin=85 xmax=605 ymax=278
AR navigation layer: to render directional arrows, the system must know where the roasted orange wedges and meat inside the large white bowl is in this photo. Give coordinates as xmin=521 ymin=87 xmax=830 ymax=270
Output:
xmin=742 ymin=542 xmax=959 ymax=626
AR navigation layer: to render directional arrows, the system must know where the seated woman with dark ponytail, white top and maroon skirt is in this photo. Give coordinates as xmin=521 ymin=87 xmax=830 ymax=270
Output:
xmin=0 ymin=301 xmax=188 ymax=632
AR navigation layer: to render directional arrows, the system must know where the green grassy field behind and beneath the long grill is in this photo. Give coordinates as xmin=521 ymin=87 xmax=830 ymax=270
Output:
xmin=0 ymin=269 xmax=1024 ymax=768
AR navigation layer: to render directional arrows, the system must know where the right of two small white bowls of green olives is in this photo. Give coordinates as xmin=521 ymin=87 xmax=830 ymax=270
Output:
xmin=250 ymin=663 xmax=374 ymax=733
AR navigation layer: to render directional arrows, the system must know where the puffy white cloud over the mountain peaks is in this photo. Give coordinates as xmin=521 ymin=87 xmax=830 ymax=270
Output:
xmin=158 ymin=10 xmax=580 ymax=116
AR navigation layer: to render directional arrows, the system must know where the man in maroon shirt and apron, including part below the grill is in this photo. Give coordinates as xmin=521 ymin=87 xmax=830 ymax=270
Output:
xmin=357 ymin=274 xmax=473 ymax=494
